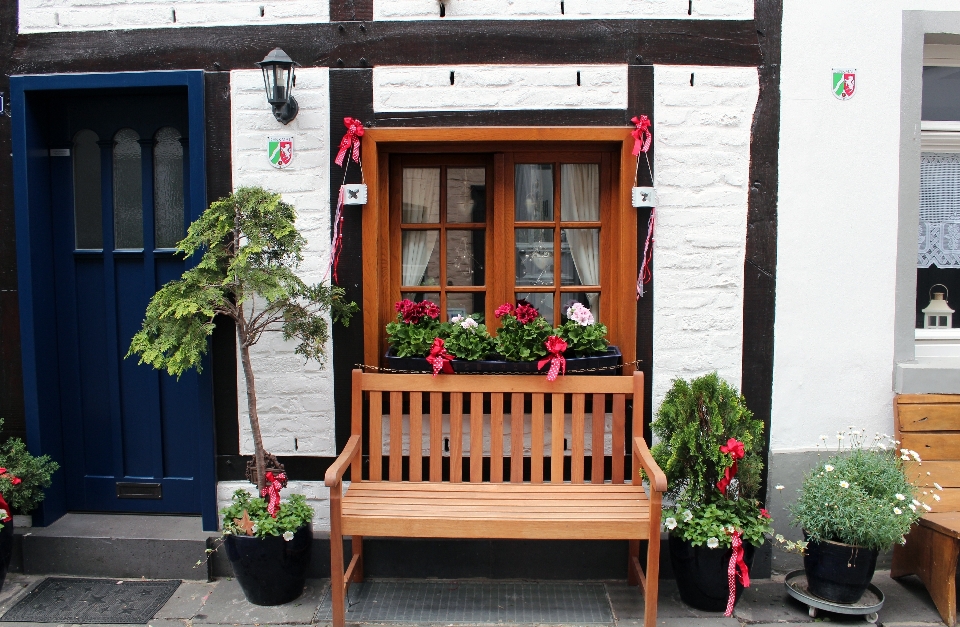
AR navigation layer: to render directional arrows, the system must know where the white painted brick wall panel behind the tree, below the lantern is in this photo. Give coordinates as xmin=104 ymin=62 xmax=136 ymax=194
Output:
xmin=230 ymin=68 xmax=337 ymax=456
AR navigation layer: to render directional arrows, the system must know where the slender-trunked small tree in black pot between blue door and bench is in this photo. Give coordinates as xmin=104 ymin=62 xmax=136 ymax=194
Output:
xmin=127 ymin=187 xmax=357 ymax=604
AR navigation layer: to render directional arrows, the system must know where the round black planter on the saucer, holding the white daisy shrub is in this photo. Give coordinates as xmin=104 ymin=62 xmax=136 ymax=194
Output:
xmin=803 ymin=540 xmax=879 ymax=603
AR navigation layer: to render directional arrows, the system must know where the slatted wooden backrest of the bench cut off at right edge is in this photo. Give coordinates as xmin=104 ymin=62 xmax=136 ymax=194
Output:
xmin=893 ymin=394 xmax=960 ymax=512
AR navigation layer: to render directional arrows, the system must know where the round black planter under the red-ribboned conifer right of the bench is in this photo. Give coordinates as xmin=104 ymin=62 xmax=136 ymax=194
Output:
xmin=670 ymin=535 xmax=754 ymax=612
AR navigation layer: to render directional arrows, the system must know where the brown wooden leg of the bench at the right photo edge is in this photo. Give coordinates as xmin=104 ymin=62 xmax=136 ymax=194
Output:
xmin=890 ymin=524 xmax=960 ymax=627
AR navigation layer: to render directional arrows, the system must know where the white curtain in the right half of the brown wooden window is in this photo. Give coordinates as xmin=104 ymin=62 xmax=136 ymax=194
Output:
xmin=560 ymin=163 xmax=600 ymax=314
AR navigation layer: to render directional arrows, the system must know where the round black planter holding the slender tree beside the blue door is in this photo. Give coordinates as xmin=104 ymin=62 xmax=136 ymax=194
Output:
xmin=224 ymin=525 xmax=313 ymax=605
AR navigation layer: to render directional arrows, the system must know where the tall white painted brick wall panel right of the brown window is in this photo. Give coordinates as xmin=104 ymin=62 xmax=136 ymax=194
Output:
xmin=652 ymin=65 xmax=758 ymax=411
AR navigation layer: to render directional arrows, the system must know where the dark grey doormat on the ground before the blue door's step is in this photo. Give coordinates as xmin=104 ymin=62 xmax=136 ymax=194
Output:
xmin=0 ymin=577 xmax=180 ymax=625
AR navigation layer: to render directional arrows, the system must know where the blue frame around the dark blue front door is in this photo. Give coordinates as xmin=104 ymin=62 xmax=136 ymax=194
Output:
xmin=10 ymin=70 xmax=219 ymax=531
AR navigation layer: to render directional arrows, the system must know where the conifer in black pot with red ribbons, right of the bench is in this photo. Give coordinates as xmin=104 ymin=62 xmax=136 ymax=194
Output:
xmin=651 ymin=372 xmax=771 ymax=616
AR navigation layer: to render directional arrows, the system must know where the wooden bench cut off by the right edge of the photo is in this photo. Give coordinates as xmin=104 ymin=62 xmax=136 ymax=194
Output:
xmin=890 ymin=394 xmax=960 ymax=627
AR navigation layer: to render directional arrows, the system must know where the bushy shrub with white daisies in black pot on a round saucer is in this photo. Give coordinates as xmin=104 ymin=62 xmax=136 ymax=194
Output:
xmin=790 ymin=427 xmax=940 ymax=603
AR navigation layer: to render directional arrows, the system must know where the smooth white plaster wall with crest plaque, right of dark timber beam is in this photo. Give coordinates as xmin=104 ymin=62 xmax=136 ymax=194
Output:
xmin=772 ymin=0 xmax=960 ymax=451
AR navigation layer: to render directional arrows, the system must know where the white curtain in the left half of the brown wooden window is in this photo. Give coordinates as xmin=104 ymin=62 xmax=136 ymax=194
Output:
xmin=402 ymin=168 xmax=440 ymax=285
